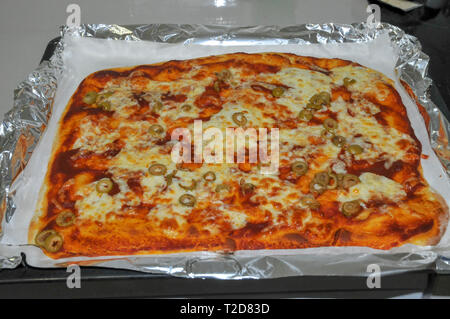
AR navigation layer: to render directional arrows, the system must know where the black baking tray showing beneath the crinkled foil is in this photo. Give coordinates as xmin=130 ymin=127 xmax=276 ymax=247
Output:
xmin=0 ymin=30 xmax=450 ymax=298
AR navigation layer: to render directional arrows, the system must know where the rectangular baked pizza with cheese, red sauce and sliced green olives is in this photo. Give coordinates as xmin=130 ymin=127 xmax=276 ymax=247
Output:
xmin=28 ymin=52 xmax=448 ymax=258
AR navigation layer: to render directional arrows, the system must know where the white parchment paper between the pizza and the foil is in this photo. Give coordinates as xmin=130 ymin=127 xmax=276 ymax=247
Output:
xmin=0 ymin=35 xmax=450 ymax=273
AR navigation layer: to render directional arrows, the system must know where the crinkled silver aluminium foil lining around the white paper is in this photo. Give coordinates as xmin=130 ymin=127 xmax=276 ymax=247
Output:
xmin=0 ymin=23 xmax=450 ymax=279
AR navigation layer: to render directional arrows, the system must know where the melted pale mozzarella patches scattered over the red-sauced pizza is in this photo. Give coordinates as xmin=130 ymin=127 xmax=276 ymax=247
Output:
xmin=68 ymin=58 xmax=413 ymax=232
